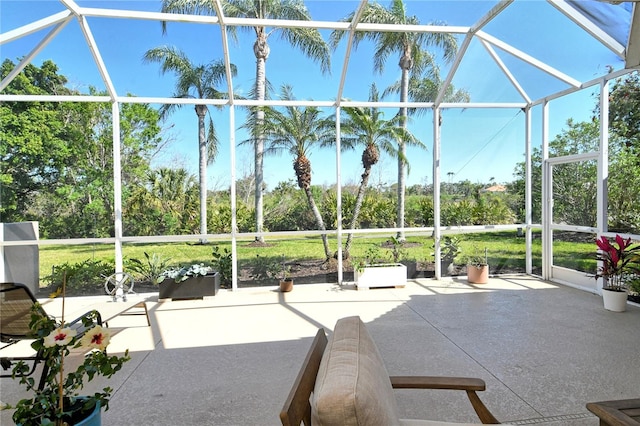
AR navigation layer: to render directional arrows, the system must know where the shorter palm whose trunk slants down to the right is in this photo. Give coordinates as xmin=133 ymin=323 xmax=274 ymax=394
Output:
xmin=255 ymin=85 xmax=335 ymax=260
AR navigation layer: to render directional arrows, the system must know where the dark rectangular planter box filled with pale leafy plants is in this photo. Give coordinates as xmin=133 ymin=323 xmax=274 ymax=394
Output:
xmin=158 ymin=263 xmax=220 ymax=300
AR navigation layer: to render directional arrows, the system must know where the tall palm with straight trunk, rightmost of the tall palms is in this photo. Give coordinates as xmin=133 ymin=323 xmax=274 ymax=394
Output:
xmin=330 ymin=0 xmax=457 ymax=240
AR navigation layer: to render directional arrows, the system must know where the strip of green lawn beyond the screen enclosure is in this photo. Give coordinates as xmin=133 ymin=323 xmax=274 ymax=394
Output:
xmin=35 ymin=231 xmax=595 ymax=285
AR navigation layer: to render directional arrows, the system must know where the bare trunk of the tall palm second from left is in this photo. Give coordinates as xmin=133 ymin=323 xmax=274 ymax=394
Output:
xmin=253 ymin=33 xmax=270 ymax=242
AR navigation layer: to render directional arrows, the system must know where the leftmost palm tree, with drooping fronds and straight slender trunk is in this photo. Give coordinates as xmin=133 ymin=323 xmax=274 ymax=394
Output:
xmin=143 ymin=46 xmax=237 ymax=243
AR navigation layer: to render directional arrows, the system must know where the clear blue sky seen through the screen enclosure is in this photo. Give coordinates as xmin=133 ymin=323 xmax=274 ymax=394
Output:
xmin=0 ymin=0 xmax=622 ymax=189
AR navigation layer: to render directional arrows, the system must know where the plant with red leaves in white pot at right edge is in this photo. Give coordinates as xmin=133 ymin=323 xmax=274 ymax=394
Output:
xmin=594 ymin=235 xmax=640 ymax=312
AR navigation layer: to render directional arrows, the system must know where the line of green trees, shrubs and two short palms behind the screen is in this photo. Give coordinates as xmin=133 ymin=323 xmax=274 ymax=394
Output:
xmin=0 ymin=60 xmax=640 ymax=246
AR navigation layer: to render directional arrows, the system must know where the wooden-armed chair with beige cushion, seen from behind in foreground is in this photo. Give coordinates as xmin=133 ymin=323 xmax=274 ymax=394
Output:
xmin=280 ymin=317 xmax=499 ymax=426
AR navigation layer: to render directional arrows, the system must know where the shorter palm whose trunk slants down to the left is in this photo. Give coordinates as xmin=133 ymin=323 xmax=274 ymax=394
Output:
xmin=340 ymin=83 xmax=424 ymax=259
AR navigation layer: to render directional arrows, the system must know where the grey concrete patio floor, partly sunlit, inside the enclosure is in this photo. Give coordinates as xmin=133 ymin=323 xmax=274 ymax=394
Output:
xmin=0 ymin=276 xmax=640 ymax=426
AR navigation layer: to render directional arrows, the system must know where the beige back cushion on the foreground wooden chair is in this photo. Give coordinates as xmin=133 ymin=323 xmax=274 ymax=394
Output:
xmin=311 ymin=317 xmax=400 ymax=426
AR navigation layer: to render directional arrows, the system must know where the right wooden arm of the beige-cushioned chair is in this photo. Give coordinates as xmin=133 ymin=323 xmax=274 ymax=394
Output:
xmin=389 ymin=376 xmax=500 ymax=424
